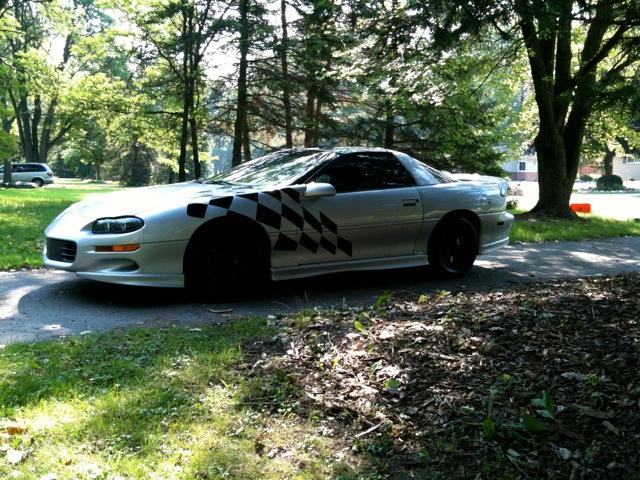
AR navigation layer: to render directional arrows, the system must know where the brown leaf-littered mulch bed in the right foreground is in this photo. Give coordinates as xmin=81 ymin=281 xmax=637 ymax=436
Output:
xmin=249 ymin=274 xmax=640 ymax=479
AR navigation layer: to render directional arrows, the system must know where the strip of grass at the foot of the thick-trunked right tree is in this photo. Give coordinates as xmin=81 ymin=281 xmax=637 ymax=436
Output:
xmin=511 ymin=211 xmax=640 ymax=243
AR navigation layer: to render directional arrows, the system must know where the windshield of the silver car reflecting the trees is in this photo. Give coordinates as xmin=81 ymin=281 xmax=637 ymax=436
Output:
xmin=207 ymin=150 xmax=331 ymax=187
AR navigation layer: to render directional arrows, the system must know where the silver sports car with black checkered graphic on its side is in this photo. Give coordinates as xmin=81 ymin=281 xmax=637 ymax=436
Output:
xmin=43 ymin=148 xmax=513 ymax=297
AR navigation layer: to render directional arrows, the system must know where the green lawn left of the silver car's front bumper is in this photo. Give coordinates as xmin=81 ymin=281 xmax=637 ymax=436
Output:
xmin=0 ymin=180 xmax=117 ymax=270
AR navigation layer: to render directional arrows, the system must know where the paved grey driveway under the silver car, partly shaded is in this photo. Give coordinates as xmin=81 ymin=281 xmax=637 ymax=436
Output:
xmin=0 ymin=237 xmax=640 ymax=345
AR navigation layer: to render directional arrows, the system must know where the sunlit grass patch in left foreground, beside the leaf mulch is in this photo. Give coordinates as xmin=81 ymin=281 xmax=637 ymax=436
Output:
xmin=0 ymin=318 xmax=350 ymax=479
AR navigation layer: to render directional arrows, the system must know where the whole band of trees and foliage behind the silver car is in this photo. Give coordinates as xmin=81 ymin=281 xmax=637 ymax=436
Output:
xmin=0 ymin=0 xmax=640 ymax=201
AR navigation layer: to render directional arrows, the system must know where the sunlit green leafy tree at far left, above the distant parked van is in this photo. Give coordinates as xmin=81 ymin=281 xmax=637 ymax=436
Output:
xmin=1 ymin=0 xmax=106 ymax=162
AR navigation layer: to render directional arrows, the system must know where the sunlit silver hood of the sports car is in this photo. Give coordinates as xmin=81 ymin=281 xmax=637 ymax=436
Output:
xmin=65 ymin=182 xmax=255 ymax=219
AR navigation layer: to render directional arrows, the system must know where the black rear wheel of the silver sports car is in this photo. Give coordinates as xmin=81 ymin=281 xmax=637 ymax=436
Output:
xmin=427 ymin=217 xmax=478 ymax=278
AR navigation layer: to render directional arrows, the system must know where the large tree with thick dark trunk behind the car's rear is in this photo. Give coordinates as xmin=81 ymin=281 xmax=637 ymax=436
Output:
xmin=412 ymin=0 xmax=640 ymax=218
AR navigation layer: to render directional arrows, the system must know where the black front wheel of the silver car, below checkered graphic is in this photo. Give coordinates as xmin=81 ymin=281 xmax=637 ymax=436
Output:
xmin=184 ymin=231 xmax=268 ymax=301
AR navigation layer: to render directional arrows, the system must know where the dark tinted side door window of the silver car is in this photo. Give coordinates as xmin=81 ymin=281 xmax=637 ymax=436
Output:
xmin=312 ymin=153 xmax=415 ymax=193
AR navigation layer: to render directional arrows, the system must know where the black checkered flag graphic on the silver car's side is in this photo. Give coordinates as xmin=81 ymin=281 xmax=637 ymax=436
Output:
xmin=187 ymin=188 xmax=352 ymax=257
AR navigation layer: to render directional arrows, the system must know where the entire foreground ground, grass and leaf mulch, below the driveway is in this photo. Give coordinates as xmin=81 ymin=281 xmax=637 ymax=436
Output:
xmin=0 ymin=274 xmax=640 ymax=479
